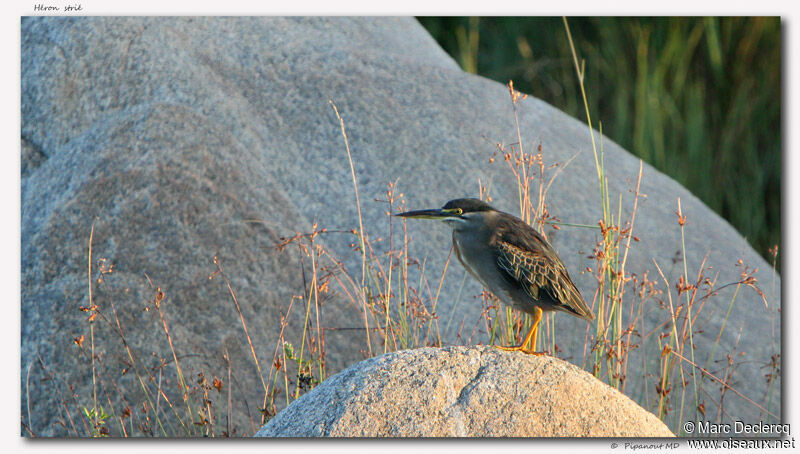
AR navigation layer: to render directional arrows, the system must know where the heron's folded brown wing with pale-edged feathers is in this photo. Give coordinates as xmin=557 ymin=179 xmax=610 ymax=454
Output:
xmin=495 ymin=221 xmax=594 ymax=320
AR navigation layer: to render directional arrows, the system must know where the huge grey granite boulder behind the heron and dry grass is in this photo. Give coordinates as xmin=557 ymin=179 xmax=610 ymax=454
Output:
xmin=21 ymin=17 xmax=780 ymax=435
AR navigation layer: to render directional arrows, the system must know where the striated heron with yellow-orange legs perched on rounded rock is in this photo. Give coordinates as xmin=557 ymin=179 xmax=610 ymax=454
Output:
xmin=396 ymin=199 xmax=594 ymax=355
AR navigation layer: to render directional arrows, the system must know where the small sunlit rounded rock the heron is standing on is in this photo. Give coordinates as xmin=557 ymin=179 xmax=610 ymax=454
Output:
xmin=256 ymin=346 xmax=674 ymax=437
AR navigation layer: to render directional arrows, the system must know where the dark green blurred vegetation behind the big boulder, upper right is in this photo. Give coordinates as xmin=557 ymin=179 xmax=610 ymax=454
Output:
xmin=418 ymin=17 xmax=781 ymax=262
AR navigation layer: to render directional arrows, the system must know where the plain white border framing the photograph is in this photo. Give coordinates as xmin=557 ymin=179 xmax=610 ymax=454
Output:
xmin=0 ymin=0 xmax=800 ymax=454
